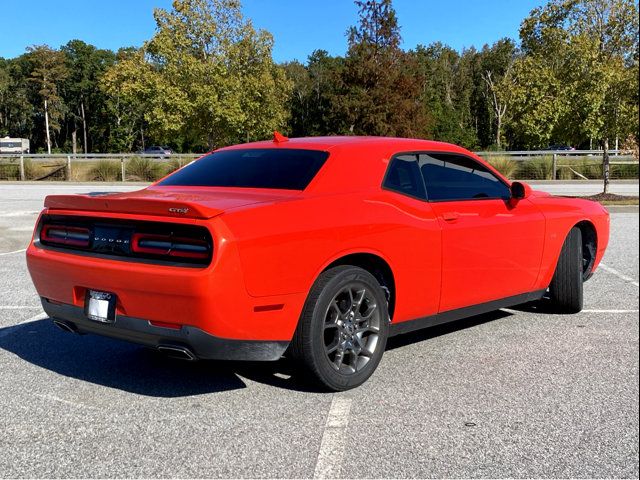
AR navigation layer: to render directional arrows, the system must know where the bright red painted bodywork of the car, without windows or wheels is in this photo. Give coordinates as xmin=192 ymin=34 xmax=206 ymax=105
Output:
xmin=27 ymin=137 xmax=609 ymax=352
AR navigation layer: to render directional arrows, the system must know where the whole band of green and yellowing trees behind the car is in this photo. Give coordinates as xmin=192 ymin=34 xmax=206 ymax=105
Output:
xmin=0 ymin=0 xmax=639 ymax=158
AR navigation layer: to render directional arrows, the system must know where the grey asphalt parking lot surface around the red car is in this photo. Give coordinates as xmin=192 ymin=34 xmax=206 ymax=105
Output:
xmin=0 ymin=184 xmax=639 ymax=478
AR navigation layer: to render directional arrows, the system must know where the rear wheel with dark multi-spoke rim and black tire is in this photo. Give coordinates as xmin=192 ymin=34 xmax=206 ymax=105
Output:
xmin=290 ymin=265 xmax=389 ymax=391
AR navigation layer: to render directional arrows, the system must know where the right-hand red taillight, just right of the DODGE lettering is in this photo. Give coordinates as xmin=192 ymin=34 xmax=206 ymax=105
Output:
xmin=131 ymin=233 xmax=211 ymax=259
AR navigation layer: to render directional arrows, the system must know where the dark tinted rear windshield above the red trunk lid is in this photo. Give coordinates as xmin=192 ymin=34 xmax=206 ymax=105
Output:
xmin=159 ymin=148 xmax=329 ymax=190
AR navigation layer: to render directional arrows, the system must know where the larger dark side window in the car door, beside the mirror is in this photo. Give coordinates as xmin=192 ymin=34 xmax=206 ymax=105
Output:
xmin=418 ymin=153 xmax=511 ymax=201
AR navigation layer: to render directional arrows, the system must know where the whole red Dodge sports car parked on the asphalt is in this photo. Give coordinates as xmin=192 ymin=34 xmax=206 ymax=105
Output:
xmin=27 ymin=134 xmax=609 ymax=390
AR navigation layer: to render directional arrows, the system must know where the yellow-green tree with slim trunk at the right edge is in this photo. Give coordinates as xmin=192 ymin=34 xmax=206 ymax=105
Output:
xmin=519 ymin=0 xmax=638 ymax=193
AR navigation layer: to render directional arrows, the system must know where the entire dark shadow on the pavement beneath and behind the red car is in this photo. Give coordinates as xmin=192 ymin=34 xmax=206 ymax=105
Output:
xmin=0 ymin=310 xmax=511 ymax=398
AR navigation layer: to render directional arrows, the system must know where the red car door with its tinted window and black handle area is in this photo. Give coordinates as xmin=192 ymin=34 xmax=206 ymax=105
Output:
xmin=418 ymin=153 xmax=545 ymax=312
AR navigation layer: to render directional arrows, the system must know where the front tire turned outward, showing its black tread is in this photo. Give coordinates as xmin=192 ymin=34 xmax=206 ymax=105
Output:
xmin=549 ymin=227 xmax=584 ymax=313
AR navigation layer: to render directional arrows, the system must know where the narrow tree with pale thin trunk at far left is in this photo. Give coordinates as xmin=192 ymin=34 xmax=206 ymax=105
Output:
xmin=27 ymin=45 xmax=68 ymax=154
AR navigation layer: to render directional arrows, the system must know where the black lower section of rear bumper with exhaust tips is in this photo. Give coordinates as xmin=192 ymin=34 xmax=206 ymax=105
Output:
xmin=41 ymin=298 xmax=289 ymax=361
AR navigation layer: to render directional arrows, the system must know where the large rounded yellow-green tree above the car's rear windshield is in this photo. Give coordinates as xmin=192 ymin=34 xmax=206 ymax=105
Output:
xmin=104 ymin=0 xmax=291 ymax=148
